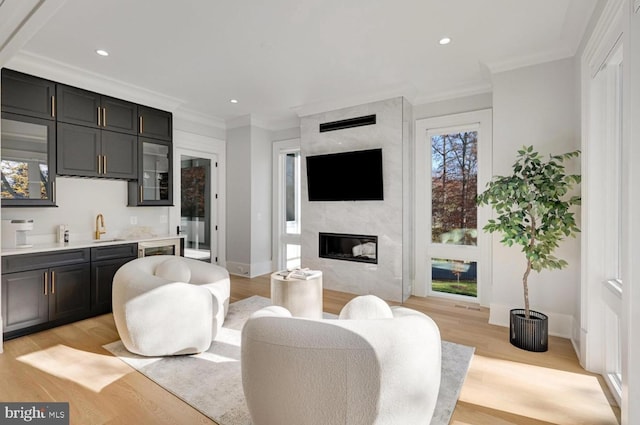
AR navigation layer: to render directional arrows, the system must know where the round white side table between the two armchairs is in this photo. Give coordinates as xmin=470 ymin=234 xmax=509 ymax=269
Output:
xmin=271 ymin=272 xmax=322 ymax=319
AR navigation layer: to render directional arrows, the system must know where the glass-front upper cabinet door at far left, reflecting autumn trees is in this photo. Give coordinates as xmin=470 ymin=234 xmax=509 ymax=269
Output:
xmin=0 ymin=112 xmax=56 ymax=207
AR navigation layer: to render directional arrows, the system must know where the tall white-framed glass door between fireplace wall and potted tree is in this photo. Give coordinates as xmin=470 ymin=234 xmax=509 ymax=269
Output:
xmin=414 ymin=110 xmax=492 ymax=301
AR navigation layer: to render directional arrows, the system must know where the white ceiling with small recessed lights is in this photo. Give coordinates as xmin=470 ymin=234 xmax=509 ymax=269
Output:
xmin=0 ymin=0 xmax=598 ymax=127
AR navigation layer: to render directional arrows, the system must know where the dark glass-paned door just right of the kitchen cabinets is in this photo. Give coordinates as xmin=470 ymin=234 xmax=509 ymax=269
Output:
xmin=180 ymin=155 xmax=212 ymax=262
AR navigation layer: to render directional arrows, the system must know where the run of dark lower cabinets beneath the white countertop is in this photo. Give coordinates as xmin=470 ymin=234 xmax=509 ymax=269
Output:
xmin=2 ymin=244 xmax=137 ymax=340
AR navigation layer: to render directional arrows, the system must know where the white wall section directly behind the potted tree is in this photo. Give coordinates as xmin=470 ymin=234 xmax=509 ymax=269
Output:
xmin=490 ymin=58 xmax=580 ymax=338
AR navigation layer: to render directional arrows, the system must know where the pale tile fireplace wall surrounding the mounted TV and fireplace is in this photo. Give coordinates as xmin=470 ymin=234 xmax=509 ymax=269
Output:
xmin=301 ymin=97 xmax=410 ymax=301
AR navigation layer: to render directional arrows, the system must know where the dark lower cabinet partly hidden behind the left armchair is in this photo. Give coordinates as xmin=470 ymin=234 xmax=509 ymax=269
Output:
xmin=91 ymin=244 xmax=138 ymax=315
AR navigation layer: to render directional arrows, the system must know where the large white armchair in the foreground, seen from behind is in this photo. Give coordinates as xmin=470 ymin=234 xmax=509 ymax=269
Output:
xmin=241 ymin=295 xmax=441 ymax=425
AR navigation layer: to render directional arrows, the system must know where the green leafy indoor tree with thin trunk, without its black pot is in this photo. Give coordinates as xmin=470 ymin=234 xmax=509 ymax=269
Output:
xmin=477 ymin=146 xmax=581 ymax=319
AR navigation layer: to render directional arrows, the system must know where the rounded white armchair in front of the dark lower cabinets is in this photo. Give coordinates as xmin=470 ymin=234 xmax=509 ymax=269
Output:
xmin=112 ymin=255 xmax=230 ymax=356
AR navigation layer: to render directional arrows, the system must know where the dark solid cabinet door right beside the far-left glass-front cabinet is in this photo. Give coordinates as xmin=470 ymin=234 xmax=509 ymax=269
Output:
xmin=57 ymin=123 xmax=102 ymax=177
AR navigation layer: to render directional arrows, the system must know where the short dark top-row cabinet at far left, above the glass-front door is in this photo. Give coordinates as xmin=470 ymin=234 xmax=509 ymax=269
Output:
xmin=2 ymin=68 xmax=56 ymax=120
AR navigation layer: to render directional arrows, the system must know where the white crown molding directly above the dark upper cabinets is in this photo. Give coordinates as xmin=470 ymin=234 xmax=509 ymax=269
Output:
xmin=7 ymin=51 xmax=184 ymax=112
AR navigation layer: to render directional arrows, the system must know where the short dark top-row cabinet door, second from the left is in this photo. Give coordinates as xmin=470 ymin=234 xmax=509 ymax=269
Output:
xmin=57 ymin=84 xmax=102 ymax=127
